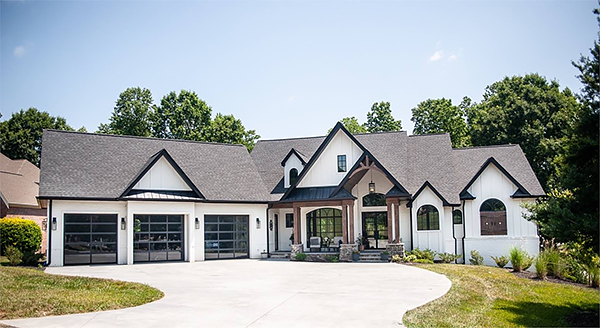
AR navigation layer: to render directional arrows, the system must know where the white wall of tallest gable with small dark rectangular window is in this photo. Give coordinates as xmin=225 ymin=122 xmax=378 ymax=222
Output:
xmin=299 ymin=131 xmax=363 ymax=187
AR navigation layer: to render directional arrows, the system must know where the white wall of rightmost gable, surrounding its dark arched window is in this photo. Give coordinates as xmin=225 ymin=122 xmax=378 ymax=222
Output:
xmin=464 ymin=165 xmax=539 ymax=265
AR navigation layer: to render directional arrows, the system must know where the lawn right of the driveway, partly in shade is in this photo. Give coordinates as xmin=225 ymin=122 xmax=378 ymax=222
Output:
xmin=403 ymin=264 xmax=600 ymax=327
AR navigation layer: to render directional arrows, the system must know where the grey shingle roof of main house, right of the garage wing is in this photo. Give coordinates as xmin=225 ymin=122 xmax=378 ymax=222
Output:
xmin=251 ymin=131 xmax=545 ymax=205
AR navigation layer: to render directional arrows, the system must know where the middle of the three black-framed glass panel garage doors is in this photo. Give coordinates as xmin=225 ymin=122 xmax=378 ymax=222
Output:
xmin=133 ymin=214 xmax=183 ymax=262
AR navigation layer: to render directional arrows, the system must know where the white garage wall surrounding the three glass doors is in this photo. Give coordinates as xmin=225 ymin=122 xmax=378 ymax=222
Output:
xmin=49 ymin=200 xmax=268 ymax=266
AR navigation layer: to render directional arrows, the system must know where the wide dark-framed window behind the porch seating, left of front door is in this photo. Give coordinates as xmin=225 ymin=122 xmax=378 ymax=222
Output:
xmin=306 ymin=208 xmax=342 ymax=245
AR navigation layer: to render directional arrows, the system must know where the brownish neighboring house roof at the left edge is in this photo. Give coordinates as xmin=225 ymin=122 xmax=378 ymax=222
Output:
xmin=0 ymin=154 xmax=40 ymax=207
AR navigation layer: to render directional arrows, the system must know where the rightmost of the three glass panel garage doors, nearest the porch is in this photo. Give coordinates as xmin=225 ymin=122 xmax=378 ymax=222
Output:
xmin=204 ymin=215 xmax=248 ymax=260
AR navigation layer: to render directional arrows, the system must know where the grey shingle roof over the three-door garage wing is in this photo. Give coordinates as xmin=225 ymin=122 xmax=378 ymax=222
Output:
xmin=40 ymin=130 xmax=270 ymax=202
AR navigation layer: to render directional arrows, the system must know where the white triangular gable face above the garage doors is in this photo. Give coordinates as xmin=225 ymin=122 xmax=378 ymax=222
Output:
xmin=133 ymin=157 xmax=191 ymax=190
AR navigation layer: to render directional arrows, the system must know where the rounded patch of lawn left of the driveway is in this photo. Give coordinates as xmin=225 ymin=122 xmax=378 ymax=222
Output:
xmin=0 ymin=267 xmax=164 ymax=319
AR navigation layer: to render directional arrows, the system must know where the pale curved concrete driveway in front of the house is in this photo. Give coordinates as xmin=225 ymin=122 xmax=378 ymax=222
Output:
xmin=4 ymin=260 xmax=451 ymax=328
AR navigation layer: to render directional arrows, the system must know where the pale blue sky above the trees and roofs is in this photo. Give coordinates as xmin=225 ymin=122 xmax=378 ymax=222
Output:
xmin=0 ymin=1 xmax=598 ymax=139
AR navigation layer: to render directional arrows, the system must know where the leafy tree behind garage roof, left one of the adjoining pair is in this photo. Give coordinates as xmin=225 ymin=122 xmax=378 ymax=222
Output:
xmin=98 ymin=87 xmax=153 ymax=137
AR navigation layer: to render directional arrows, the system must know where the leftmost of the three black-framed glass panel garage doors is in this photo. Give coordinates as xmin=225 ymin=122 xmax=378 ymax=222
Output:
xmin=64 ymin=214 xmax=118 ymax=265
